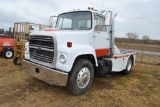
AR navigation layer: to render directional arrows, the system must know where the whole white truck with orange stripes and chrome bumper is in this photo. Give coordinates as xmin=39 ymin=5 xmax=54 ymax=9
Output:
xmin=22 ymin=9 xmax=136 ymax=95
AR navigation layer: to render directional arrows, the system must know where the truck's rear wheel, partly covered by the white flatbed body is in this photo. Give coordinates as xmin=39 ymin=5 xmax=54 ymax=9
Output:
xmin=123 ymin=57 xmax=133 ymax=75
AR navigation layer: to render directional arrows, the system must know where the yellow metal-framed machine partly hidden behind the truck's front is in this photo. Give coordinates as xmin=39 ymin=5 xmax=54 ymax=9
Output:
xmin=13 ymin=22 xmax=50 ymax=65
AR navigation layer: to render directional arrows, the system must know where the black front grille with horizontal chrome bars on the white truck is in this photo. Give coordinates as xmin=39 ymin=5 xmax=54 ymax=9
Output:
xmin=29 ymin=35 xmax=54 ymax=63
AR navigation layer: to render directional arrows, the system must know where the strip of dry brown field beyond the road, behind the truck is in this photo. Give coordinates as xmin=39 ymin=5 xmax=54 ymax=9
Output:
xmin=116 ymin=43 xmax=160 ymax=52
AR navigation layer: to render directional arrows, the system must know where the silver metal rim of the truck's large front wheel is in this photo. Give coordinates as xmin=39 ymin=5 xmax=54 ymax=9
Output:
xmin=77 ymin=67 xmax=90 ymax=88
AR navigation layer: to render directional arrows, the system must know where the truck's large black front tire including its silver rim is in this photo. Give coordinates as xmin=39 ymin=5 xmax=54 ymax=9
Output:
xmin=67 ymin=59 xmax=94 ymax=96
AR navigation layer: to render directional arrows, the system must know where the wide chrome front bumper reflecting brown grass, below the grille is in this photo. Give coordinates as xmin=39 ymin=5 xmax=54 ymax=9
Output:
xmin=22 ymin=60 xmax=68 ymax=86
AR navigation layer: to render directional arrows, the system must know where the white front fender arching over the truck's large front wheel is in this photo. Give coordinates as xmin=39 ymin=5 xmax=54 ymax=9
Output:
xmin=56 ymin=45 xmax=98 ymax=72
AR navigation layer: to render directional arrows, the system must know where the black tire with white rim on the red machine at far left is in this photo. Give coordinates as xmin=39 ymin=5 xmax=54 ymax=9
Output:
xmin=2 ymin=48 xmax=14 ymax=59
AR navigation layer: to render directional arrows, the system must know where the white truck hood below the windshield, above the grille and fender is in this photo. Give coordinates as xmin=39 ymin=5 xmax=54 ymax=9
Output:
xmin=31 ymin=29 xmax=93 ymax=46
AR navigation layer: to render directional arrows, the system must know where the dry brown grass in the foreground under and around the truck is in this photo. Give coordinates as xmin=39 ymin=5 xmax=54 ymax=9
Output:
xmin=0 ymin=58 xmax=160 ymax=107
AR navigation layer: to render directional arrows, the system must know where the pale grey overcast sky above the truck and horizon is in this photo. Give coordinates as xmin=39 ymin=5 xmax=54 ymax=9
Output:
xmin=0 ymin=0 xmax=160 ymax=40
